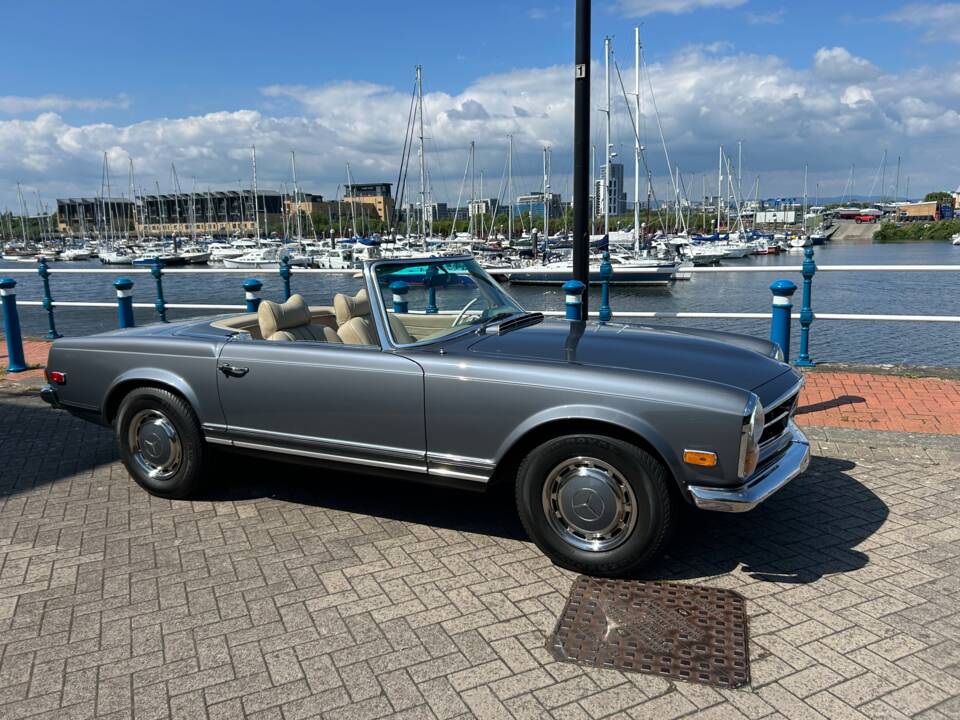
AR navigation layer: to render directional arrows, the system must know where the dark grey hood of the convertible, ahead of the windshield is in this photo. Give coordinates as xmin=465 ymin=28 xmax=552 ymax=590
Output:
xmin=469 ymin=319 xmax=789 ymax=390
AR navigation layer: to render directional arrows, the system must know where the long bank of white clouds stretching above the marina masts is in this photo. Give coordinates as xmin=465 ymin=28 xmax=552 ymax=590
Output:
xmin=0 ymin=47 xmax=960 ymax=208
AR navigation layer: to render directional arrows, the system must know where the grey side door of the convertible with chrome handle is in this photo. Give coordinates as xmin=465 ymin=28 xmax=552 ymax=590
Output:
xmin=217 ymin=339 xmax=426 ymax=472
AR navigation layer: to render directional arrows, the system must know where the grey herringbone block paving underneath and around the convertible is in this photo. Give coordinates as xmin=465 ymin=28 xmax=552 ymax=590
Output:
xmin=0 ymin=392 xmax=960 ymax=720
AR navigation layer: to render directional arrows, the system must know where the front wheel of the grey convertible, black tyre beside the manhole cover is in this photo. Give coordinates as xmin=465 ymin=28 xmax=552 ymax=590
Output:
xmin=516 ymin=435 xmax=677 ymax=577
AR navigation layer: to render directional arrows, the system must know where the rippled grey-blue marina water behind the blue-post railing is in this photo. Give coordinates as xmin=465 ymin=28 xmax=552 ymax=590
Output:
xmin=0 ymin=242 xmax=960 ymax=367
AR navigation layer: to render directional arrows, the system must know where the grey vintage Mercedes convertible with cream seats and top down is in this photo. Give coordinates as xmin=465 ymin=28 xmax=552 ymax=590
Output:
xmin=43 ymin=257 xmax=810 ymax=575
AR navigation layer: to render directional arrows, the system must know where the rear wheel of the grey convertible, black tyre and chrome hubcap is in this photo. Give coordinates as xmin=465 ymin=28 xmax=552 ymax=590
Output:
xmin=114 ymin=387 xmax=207 ymax=498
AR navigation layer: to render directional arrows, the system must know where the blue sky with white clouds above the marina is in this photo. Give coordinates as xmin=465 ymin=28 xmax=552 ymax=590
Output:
xmin=0 ymin=0 xmax=960 ymax=204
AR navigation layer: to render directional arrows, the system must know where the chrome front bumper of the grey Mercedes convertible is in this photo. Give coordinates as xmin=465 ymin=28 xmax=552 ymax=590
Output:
xmin=688 ymin=420 xmax=810 ymax=512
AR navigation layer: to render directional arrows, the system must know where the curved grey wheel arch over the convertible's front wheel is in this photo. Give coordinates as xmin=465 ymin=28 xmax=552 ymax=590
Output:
xmin=491 ymin=406 xmax=687 ymax=498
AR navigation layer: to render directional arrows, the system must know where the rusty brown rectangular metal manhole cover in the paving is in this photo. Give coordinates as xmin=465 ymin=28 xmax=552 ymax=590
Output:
xmin=547 ymin=575 xmax=750 ymax=688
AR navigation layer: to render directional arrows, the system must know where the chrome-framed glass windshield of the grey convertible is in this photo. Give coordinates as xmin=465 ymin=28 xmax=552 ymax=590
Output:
xmin=374 ymin=259 xmax=523 ymax=345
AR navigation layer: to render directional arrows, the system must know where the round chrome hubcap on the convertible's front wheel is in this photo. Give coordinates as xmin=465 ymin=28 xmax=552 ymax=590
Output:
xmin=543 ymin=457 xmax=637 ymax=552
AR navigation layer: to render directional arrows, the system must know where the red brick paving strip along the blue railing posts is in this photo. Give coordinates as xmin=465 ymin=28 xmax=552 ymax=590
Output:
xmin=0 ymin=340 xmax=960 ymax=435
